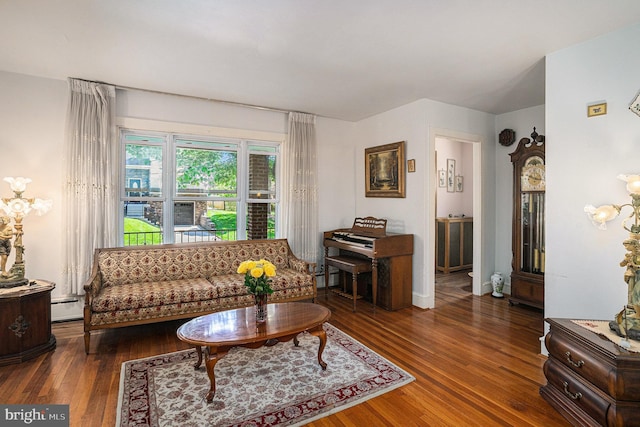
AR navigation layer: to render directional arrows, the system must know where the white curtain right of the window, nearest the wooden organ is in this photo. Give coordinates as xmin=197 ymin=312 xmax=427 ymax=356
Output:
xmin=282 ymin=113 xmax=319 ymax=262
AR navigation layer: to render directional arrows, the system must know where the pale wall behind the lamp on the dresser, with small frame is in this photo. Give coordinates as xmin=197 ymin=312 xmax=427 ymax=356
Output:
xmin=545 ymin=24 xmax=640 ymax=319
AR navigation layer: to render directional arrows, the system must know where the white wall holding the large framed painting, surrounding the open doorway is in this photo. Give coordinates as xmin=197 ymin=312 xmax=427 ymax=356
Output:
xmin=355 ymin=99 xmax=495 ymax=308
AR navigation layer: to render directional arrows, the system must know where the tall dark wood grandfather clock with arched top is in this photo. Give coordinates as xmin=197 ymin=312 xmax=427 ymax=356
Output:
xmin=509 ymin=128 xmax=546 ymax=308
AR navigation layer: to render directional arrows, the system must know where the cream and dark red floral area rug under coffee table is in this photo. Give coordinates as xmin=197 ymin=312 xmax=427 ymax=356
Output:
xmin=116 ymin=324 xmax=415 ymax=427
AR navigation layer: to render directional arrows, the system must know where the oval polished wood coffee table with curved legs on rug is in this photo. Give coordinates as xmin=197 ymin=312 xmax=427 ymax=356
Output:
xmin=177 ymin=302 xmax=331 ymax=402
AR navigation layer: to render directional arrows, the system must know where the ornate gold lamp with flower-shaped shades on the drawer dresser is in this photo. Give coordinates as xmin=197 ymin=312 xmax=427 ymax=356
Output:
xmin=584 ymin=174 xmax=640 ymax=340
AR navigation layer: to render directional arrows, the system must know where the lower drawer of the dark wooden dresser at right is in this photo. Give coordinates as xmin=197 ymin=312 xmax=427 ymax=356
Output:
xmin=543 ymin=358 xmax=615 ymax=426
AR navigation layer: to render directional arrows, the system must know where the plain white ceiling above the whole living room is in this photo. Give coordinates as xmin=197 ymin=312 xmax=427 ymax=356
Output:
xmin=0 ymin=0 xmax=640 ymax=121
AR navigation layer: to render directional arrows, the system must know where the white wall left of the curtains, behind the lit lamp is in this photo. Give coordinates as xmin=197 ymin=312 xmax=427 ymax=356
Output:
xmin=0 ymin=71 xmax=67 ymax=308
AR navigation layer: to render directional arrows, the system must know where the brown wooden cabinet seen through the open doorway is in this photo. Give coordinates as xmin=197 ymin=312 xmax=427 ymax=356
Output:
xmin=436 ymin=217 xmax=473 ymax=273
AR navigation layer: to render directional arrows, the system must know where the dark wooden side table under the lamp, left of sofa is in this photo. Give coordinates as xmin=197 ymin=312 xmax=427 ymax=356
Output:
xmin=0 ymin=280 xmax=56 ymax=366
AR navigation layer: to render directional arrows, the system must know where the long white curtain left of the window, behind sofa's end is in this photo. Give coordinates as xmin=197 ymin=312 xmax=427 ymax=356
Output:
xmin=61 ymin=79 xmax=118 ymax=295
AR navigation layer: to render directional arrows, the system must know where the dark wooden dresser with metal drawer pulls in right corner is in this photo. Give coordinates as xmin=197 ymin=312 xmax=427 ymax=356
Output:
xmin=540 ymin=319 xmax=640 ymax=426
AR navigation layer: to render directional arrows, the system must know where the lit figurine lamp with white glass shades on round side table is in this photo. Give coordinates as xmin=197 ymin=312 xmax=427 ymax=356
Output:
xmin=0 ymin=177 xmax=51 ymax=288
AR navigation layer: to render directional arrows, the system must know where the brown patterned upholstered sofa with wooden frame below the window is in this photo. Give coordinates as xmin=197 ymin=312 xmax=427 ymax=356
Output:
xmin=84 ymin=239 xmax=317 ymax=353
